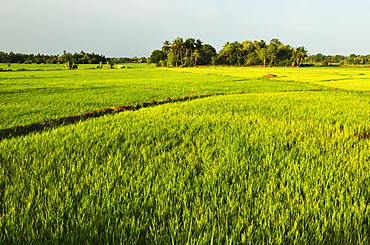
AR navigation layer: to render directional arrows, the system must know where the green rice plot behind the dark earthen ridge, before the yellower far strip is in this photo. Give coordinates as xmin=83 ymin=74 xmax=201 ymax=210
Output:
xmin=0 ymin=64 xmax=319 ymax=129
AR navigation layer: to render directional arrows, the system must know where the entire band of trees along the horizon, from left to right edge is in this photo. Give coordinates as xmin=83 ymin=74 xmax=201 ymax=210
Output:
xmin=0 ymin=37 xmax=370 ymax=69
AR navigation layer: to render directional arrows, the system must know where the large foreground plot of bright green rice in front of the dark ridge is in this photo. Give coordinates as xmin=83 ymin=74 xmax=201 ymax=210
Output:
xmin=0 ymin=91 xmax=370 ymax=244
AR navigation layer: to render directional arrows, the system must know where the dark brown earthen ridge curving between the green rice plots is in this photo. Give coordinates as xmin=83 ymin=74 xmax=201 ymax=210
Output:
xmin=0 ymin=93 xmax=218 ymax=140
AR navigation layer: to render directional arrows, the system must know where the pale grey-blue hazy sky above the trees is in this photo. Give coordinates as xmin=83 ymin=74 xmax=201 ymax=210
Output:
xmin=0 ymin=0 xmax=370 ymax=57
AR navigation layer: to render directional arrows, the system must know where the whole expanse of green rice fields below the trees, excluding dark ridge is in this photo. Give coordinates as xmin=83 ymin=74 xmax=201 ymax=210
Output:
xmin=0 ymin=66 xmax=370 ymax=244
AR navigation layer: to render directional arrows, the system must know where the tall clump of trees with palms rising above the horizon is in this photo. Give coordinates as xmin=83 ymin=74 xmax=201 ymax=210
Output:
xmin=150 ymin=37 xmax=308 ymax=66
